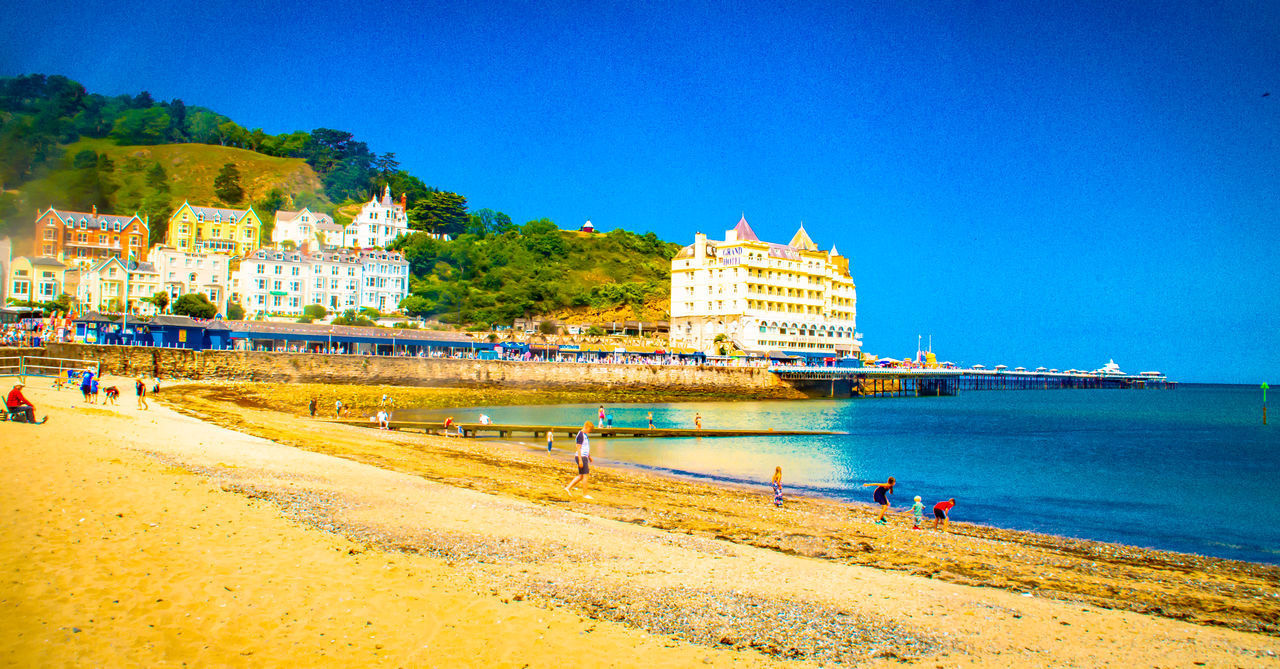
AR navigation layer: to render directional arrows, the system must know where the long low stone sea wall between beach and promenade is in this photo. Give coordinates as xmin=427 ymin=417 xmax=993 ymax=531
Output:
xmin=45 ymin=344 xmax=804 ymax=398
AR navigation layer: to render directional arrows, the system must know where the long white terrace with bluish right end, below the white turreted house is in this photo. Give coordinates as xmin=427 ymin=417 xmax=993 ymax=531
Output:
xmin=239 ymin=248 xmax=408 ymax=316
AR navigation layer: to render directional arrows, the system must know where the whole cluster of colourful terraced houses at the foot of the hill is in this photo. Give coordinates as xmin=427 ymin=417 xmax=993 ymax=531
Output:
xmin=4 ymin=188 xmax=410 ymax=317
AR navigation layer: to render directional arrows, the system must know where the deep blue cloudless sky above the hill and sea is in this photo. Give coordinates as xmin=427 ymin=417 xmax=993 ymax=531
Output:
xmin=0 ymin=0 xmax=1280 ymax=382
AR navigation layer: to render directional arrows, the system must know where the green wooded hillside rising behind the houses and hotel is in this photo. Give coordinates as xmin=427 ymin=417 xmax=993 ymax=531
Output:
xmin=0 ymin=74 xmax=680 ymax=325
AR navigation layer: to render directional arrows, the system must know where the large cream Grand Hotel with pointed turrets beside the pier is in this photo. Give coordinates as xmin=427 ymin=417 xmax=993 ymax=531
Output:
xmin=671 ymin=216 xmax=861 ymax=357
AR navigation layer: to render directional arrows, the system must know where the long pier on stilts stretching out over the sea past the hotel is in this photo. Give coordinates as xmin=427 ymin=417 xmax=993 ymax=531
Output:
xmin=769 ymin=367 xmax=1176 ymax=397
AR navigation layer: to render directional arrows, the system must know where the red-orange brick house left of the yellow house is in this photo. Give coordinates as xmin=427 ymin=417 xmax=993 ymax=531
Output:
xmin=33 ymin=207 xmax=150 ymax=265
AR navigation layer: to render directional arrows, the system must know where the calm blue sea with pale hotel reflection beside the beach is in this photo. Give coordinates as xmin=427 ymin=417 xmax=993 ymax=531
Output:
xmin=398 ymin=385 xmax=1280 ymax=564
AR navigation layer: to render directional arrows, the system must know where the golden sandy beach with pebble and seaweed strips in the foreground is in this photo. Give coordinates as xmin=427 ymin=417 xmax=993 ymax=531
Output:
xmin=0 ymin=379 xmax=1280 ymax=666
